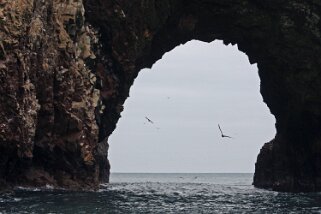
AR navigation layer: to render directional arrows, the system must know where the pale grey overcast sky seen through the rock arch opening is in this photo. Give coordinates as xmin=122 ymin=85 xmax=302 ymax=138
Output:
xmin=109 ymin=41 xmax=275 ymax=172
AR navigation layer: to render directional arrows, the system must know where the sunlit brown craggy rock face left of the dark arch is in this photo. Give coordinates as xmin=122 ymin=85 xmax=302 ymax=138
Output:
xmin=0 ymin=0 xmax=107 ymax=188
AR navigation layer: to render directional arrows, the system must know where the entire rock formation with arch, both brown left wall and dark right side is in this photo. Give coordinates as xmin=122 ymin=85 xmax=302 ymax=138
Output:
xmin=0 ymin=0 xmax=321 ymax=191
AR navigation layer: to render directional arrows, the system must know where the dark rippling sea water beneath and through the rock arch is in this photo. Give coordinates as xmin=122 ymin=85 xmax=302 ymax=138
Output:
xmin=0 ymin=173 xmax=321 ymax=214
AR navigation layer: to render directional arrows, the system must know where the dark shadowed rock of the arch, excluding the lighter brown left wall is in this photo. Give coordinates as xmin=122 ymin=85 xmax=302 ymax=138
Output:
xmin=86 ymin=0 xmax=321 ymax=191
